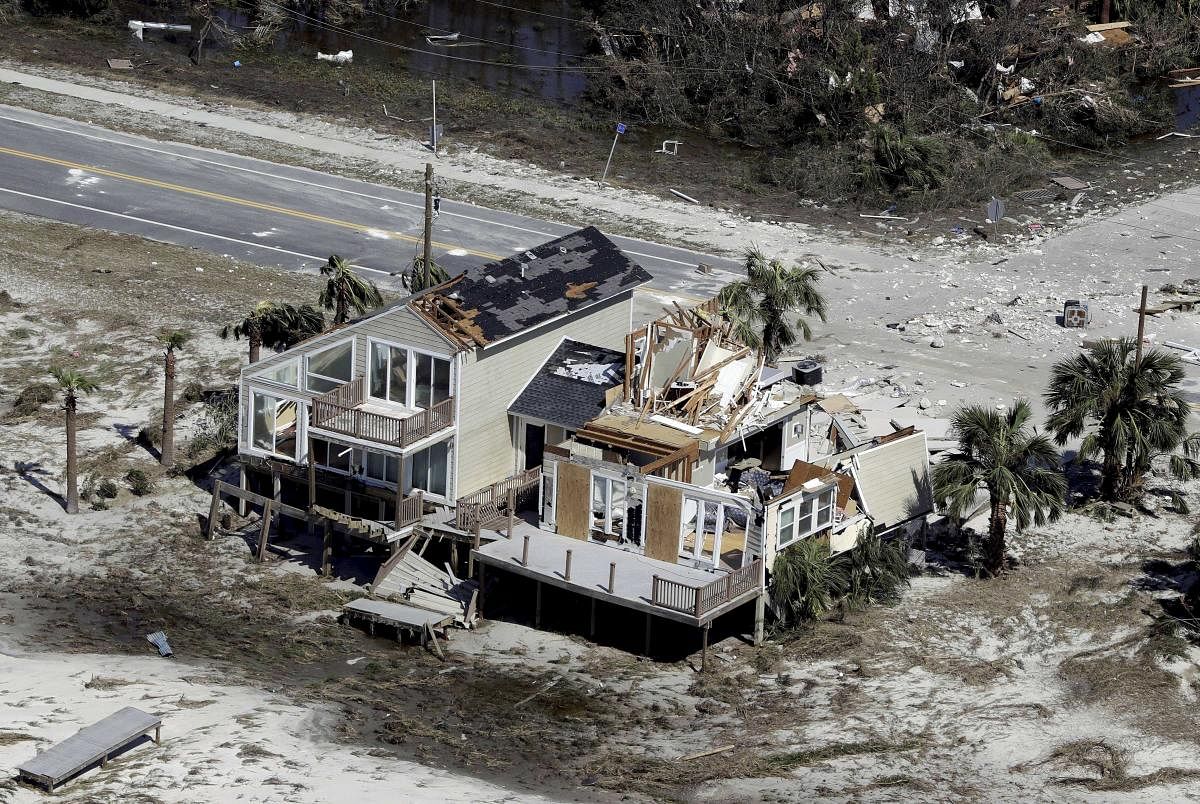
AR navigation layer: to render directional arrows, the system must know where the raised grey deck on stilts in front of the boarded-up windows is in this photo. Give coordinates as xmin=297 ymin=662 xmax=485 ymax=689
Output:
xmin=472 ymin=527 xmax=762 ymax=626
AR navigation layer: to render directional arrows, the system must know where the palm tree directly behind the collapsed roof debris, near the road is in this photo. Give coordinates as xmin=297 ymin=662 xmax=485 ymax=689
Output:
xmin=716 ymin=250 xmax=826 ymax=364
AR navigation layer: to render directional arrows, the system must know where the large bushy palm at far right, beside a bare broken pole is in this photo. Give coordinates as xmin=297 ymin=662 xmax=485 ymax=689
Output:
xmin=1045 ymin=338 xmax=1200 ymax=502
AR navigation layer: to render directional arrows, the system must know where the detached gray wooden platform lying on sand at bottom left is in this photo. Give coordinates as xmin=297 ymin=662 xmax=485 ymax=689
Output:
xmin=17 ymin=707 xmax=162 ymax=791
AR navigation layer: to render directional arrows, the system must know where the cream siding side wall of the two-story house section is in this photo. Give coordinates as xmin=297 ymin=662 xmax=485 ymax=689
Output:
xmin=457 ymin=292 xmax=634 ymax=497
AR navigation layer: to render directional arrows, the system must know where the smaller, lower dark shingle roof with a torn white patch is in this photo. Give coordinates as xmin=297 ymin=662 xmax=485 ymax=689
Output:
xmin=509 ymin=340 xmax=625 ymax=430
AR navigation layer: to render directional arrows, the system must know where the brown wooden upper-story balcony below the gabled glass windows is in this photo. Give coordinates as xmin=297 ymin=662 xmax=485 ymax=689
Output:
xmin=308 ymin=377 xmax=455 ymax=449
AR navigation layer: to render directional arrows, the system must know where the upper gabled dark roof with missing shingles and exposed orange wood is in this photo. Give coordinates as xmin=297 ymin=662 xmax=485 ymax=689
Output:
xmin=414 ymin=227 xmax=652 ymax=346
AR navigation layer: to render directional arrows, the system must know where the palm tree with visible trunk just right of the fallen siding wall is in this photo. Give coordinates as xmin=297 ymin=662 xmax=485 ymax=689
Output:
xmin=934 ymin=400 xmax=1067 ymax=575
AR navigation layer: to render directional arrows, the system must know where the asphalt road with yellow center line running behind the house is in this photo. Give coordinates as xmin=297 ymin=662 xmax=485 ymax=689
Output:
xmin=0 ymin=106 xmax=734 ymax=298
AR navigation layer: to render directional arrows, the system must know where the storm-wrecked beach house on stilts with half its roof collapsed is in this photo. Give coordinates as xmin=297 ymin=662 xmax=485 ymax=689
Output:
xmin=235 ymin=228 xmax=932 ymax=652
